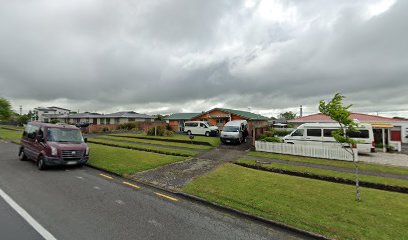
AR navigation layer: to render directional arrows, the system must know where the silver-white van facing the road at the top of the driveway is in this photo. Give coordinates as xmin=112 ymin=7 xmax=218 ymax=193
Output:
xmin=220 ymin=120 xmax=248 ymax=143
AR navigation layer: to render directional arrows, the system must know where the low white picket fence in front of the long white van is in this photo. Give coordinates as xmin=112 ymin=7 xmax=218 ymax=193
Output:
xmin=255 ymin=141 xmax=358 ymax=161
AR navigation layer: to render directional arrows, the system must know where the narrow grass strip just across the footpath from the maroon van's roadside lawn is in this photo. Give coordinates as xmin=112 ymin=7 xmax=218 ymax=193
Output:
xmin=88 ymin=138 xmax=198 ymax=157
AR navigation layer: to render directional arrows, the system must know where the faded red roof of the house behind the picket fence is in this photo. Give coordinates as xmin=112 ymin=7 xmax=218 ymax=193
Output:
xmin=288 ymin=113 xmax=407 ymax=123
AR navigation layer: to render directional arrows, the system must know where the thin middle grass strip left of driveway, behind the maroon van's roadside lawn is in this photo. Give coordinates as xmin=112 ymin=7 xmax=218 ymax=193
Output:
xmin=88 ymin=138 xmax=198 ymax=156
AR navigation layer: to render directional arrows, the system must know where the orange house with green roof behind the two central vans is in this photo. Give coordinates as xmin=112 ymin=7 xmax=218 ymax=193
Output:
xmin=165 ymin=108 xmax=268 ymax=134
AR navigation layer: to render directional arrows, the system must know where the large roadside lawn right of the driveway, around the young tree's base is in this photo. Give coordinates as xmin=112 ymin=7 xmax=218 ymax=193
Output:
xmin=183 ymin=163 xmax=408 ymax=239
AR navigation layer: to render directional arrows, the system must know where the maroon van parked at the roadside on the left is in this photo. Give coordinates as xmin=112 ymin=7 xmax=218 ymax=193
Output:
xmin=18 ymin=122 xmax=89 ymax=170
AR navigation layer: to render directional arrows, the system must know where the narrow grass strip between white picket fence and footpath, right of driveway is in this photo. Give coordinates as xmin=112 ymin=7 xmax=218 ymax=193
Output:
xmin=248 ymin=151 xmax=408 ymax=175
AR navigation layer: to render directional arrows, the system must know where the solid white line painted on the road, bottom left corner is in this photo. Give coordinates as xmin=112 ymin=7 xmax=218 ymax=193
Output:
xmin=0 ymin=189 xmax=56 ymax=240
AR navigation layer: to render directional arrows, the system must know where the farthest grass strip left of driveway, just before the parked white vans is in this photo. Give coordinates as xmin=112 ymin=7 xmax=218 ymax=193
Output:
xmin=110 ymin=133 xmax=221 ymax=147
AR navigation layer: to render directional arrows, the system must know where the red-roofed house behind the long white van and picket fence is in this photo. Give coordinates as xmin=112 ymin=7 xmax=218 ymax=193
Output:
xmin=288 ymin=113 xmax=408 ymax=143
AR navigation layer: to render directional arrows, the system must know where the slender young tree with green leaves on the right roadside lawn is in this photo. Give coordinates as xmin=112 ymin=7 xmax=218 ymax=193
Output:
xmin=319 ymin=93 xmax=361 ymax=201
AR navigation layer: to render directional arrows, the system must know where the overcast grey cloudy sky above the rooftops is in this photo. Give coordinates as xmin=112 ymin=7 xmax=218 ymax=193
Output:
xmin=0 ymin=0 xmax=408 ymax=117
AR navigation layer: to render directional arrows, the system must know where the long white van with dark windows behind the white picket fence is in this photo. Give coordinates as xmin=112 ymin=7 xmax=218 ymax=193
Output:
xmin=283 ymin=123 xmax=375 ymax=153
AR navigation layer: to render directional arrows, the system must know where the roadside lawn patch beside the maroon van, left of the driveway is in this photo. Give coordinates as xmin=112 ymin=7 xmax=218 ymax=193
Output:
xmin=88 ymin=143 xmax=186 ymax=176
